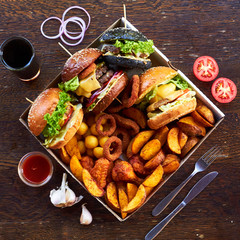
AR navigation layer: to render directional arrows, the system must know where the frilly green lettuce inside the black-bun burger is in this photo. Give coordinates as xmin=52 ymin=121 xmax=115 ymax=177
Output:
xmin=114 ymin=40 xmax=154 ymax=56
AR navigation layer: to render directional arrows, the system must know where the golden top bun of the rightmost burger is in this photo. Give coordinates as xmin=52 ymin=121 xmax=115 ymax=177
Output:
xmin=137 ymin=66 xmax=177 ymax=102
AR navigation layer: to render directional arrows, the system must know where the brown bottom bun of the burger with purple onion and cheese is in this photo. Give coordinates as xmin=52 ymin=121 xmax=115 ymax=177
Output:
xmin=93 ymin=73 xmax=128 ymax=113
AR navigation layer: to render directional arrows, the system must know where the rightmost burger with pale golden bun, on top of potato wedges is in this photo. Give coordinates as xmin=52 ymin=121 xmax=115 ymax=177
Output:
xmin=136 ymin=66 xmax=197 ymax=129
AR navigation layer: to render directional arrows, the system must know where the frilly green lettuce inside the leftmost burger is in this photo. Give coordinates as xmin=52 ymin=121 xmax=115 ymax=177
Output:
xmin=42 ymin=92 xmax=71 ymax=138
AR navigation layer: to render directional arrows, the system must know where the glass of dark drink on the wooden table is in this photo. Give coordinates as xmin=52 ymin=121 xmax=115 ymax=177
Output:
xmin=0 ymin=36 xmax=40 ymax=81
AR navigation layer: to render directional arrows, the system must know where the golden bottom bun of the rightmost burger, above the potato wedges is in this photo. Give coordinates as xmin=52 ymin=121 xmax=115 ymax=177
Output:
xmin=147 ymin=98 xmax=197 ymax=129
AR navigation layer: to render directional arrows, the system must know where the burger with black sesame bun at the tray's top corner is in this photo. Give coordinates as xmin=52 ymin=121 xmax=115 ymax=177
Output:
xmin=100 ymin=27 xmax=154 ymax=69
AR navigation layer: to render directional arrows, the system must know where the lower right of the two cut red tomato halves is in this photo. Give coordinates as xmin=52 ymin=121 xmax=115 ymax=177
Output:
xmin=211 ymin=78 xmax=237 ymax=103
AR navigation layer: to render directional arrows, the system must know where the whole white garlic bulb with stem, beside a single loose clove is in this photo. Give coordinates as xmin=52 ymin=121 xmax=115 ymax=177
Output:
xmin=49 ymin=173 xmax=83 ymax=208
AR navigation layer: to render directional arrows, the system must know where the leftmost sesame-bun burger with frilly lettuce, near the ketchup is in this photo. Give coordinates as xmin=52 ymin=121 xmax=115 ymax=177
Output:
xmin=28 ymin=88 xmax=83 ymax=149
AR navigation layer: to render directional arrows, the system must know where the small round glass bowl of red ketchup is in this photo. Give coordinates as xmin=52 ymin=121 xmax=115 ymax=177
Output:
xmin=18 ymin=152 xmax=53 ymax=187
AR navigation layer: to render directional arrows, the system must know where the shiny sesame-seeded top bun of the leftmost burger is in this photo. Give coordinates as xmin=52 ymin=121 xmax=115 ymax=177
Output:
xmin=28 ymin=88 xmax=61 ymax=136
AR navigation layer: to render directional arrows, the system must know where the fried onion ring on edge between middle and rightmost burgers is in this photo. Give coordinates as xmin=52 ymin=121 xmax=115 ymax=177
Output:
xmin=122 ymin=75 xmax=140 ymax=108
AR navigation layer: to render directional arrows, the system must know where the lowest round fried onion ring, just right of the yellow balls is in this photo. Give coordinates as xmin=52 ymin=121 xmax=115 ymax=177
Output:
xmin=103 ymin=136 xmax=122 ymax=161
